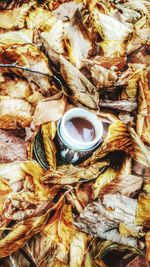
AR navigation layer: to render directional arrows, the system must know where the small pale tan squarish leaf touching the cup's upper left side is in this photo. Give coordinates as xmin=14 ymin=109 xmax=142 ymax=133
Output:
xmin=33 ymin=93 xmax=67 ymax=125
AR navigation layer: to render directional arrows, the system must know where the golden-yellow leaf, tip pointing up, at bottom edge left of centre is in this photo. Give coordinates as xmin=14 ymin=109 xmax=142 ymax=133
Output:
xmin=28 ymin=204 xmax=77 ymax=266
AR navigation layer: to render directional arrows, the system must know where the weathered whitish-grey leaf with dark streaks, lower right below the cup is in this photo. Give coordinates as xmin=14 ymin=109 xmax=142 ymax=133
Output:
xmin=75 ymin=200 xmax=137 ymax=248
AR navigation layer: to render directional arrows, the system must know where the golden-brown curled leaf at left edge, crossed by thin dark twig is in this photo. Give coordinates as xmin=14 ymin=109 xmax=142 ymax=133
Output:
xmin=0 ymin=37 xmax=52 ymax=96
